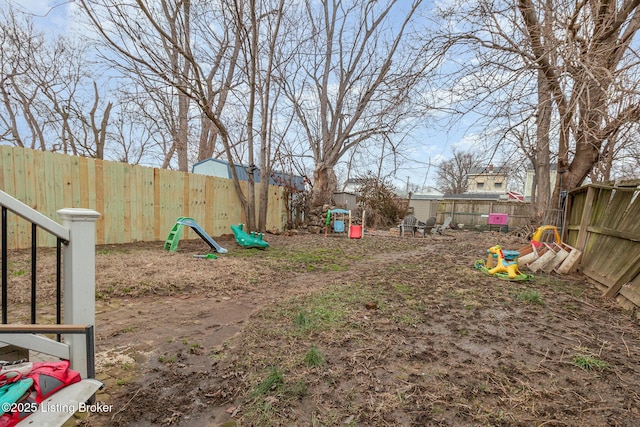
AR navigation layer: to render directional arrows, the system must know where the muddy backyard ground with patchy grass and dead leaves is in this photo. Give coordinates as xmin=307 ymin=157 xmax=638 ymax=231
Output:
xmin=3 ymin=230 xmax=640 ymax=426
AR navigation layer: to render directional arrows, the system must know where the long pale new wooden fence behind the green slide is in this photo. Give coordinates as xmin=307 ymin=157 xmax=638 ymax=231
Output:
xmin=0 ymin=146 xmax=286 ymax=249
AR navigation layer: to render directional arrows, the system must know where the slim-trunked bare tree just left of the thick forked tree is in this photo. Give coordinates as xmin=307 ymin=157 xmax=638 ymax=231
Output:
xmin=428 ymin=0 xmax=554 ymax=215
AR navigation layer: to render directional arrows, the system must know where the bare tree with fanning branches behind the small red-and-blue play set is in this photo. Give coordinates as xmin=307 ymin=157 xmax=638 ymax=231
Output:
xmin=279 ymin=0 xmax=431 ymax=206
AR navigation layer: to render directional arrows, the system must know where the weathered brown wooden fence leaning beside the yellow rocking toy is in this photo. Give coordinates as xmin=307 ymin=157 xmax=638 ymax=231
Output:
xmin=565 ymin=181 xmax=640 ymax=308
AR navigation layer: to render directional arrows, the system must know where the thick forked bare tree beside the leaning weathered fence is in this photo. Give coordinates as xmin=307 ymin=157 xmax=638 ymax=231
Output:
xmin=518 ymin=0 xmax=640 ymax=206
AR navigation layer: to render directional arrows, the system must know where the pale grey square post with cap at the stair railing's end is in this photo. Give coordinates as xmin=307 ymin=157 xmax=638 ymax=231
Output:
xmin=57 ymin=208 xmax=100 ymax=378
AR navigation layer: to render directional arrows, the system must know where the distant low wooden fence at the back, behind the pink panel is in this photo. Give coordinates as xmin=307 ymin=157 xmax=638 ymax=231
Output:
xmin=436 ymin=200 xmax=531 ymax=229
